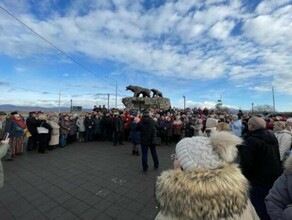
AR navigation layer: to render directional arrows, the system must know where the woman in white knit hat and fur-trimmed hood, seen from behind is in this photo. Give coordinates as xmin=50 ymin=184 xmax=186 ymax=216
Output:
xmin=155 ymin=131 xmax=259 ymax=220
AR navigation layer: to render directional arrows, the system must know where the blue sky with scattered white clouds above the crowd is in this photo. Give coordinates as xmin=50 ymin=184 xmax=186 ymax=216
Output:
xmin=0 ymin=0 xmax=292 ymax=111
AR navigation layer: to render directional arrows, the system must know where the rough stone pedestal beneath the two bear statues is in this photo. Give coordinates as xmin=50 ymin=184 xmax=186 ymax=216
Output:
xmin=122 ymin=97 xmax=171 ymax=110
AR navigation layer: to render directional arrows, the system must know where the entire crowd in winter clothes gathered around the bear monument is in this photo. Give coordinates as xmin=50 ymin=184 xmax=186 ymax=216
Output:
xmin=0 ymin=106 xmax=292 ymax=220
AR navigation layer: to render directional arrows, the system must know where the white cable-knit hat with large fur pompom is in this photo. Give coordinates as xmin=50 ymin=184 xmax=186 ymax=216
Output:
xmin=175 ymin=131 xmax=242 ymax=171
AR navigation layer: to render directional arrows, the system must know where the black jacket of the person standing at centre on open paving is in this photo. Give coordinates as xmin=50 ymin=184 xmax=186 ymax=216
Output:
xmin=137 ymin=116 xmax=156 ymax=145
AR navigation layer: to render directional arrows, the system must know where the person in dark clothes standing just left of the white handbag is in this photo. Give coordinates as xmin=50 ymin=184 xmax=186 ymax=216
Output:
xmin=26 ymin=112 xmax=40 ymax=151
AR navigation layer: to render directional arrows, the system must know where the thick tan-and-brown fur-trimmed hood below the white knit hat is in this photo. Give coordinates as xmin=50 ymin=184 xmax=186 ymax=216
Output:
xmin=155 ymin=164 xmax=249 ymax=219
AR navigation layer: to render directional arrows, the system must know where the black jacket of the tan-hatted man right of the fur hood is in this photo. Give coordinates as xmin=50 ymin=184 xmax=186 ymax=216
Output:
xmin=239 ymin=129 xmax=282 ymax=188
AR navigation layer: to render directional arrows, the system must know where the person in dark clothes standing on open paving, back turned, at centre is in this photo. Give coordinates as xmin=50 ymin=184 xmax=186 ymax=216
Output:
xmin=137 ymin=112 xmax=159 ymax=172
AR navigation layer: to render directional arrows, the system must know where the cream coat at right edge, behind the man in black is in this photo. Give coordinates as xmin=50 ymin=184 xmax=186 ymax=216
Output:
xmin=274 ymin=129 xmax=292 ymax=161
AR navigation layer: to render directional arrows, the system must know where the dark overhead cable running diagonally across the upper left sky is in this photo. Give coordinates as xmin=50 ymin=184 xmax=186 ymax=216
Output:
xmin=0 ymin=6 xmax=126 ymax=95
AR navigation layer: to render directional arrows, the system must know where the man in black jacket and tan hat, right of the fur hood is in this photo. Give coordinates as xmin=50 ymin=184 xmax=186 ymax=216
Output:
xmin=239 ymin=116 xmax=282 ymax=220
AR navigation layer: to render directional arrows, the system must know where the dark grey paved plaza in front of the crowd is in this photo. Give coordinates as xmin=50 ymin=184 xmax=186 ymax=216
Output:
xmin=0 ymin=142 xmax=174 ymax=220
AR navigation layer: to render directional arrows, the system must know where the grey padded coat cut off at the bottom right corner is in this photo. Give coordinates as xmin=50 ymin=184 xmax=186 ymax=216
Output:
xmin=265 ymin=156 xmax=292 ymax=220
